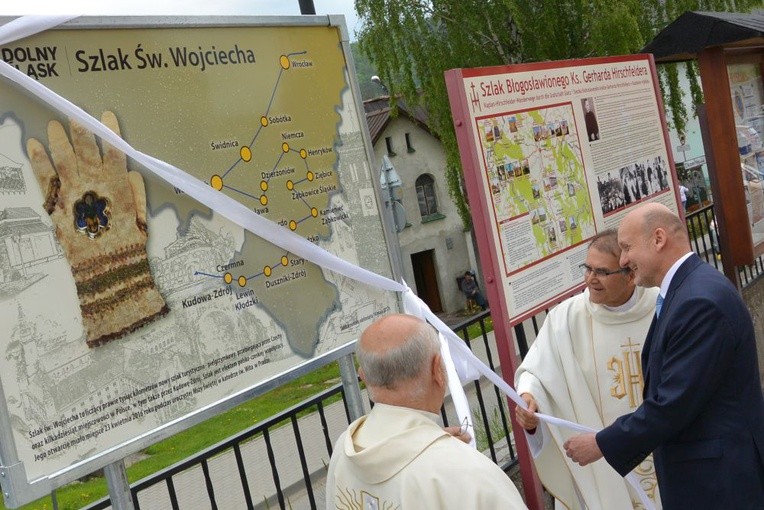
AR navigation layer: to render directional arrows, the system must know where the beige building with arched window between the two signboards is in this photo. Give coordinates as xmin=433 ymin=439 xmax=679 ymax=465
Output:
xmin=364 ymin=97 xmax=482 ymax=313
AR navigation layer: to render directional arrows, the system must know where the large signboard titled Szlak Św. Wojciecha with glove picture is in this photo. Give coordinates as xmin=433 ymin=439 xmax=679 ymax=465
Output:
xmin=0 ymin=17 xmax=397 ymax=494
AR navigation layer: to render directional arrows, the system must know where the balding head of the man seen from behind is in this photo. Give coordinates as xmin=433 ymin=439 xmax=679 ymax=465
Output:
xmin=356 ymin=314 xmax=445 ymax=412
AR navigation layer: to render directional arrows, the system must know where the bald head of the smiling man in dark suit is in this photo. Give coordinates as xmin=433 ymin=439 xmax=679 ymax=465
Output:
xmin=618 ymin=202 xmax=691 ymax=287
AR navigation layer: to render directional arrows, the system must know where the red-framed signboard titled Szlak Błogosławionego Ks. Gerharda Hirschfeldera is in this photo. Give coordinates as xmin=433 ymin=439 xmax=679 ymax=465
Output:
xmin=446 ymin=55 xmax=677 ymax=323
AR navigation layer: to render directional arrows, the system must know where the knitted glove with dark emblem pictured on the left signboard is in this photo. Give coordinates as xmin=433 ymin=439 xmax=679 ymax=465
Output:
xmin=27 ymin=111 xmax=168 ymax=347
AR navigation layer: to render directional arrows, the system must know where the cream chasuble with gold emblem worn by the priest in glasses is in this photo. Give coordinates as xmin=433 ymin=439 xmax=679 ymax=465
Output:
xmin=515 ymin=287 xmax=661 ymax=510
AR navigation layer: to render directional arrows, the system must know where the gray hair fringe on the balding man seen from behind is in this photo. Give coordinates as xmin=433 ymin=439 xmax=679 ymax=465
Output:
xmin=356 ymin=321 xmax=440 ymax=390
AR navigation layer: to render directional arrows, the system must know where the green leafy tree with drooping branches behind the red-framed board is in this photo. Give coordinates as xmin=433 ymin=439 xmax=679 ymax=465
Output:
xmin=355 ymin=0 xmax=761 ymax=228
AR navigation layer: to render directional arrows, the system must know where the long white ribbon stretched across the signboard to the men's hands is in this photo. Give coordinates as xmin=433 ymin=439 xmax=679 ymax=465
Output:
xmin=0 ymin=16 xmax=654 ymax=510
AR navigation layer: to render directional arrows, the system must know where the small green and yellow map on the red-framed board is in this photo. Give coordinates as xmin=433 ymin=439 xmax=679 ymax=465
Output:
xmin=477 ymin=103 xmax=595 ymax=274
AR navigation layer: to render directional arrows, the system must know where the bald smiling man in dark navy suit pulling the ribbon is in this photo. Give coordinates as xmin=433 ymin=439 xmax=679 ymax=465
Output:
xmin=565 ymin=203 xmax=764 ymax=510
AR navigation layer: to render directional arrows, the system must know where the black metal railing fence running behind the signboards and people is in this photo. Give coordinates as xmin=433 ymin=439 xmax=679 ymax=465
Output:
xmin=79 ymin=205 xmax=764 ymax=510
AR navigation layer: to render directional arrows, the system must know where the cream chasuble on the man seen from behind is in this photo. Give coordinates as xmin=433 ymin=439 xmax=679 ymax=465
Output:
xmin=326 ymin=404 xmax=527 ymax=510
